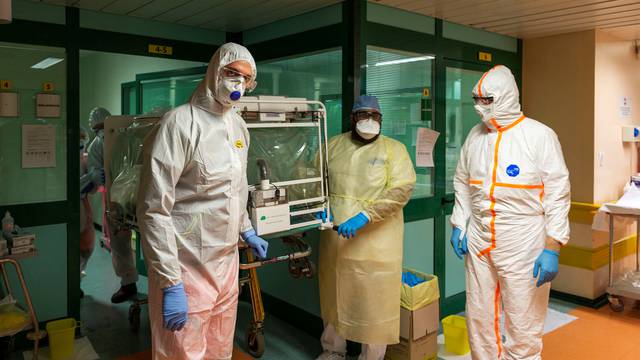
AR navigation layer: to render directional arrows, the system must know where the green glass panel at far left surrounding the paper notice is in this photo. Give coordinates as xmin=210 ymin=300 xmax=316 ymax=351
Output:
xmin=0 ymin=43 xmax=67 ymax=206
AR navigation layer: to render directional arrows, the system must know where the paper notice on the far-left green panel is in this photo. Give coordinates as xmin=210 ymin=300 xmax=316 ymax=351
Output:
xmin=22 ymin=125 xmax=56 ymax=169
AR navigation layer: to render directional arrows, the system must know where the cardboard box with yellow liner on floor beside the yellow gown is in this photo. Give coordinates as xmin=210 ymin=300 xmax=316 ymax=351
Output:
xmin=385 ymin=269 xmax=440 ymax=360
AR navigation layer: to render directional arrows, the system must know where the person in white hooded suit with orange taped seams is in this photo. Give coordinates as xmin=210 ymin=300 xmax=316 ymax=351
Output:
xmin=451 ymin=66 xmax=571 ymax=360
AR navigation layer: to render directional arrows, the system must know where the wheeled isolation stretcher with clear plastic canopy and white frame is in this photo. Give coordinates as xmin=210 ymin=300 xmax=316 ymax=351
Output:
xmin=104 ymin=97 xmax=332 ymax=357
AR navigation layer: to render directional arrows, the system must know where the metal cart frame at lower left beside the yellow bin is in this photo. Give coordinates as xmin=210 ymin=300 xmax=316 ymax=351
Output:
xmin=0 ymin=251 xmax=47 ymax=360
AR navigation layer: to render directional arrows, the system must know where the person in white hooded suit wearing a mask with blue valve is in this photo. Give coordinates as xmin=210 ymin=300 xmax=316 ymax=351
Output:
xmin=137 ymin=43 xmax=268 ymax=359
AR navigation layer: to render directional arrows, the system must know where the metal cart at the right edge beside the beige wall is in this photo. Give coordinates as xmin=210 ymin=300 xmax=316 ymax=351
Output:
xmin=607 ymin=209 xmax=640 ymax=312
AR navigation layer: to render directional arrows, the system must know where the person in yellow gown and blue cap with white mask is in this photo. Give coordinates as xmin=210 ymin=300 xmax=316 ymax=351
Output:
xmin=318 ymin=96 xmax=416 ymax=360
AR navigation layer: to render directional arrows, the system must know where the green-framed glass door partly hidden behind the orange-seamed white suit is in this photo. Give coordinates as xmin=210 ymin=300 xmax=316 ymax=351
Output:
xmin=436 ymin=62 xmax=488 ymax=313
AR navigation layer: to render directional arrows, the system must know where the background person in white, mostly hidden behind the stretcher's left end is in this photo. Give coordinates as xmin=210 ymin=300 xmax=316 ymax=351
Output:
xmin=88 ymin=107 xmax=138 ymax=304
